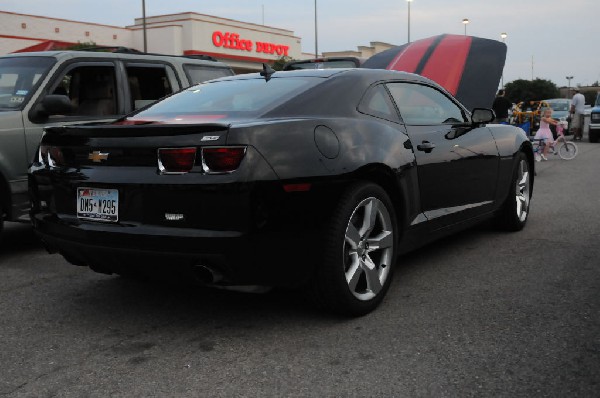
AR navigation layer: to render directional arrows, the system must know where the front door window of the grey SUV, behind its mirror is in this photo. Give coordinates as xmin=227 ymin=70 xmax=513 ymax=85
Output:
xmin=51 ymin=65 xmax=118 ymax=116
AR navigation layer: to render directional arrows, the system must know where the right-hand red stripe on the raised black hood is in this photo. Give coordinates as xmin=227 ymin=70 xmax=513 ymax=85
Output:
xmin=421 ymin=35 xmax=472 ymax=95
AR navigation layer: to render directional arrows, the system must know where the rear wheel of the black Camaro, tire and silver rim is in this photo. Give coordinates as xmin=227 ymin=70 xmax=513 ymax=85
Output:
xmin=309 ymin=182 xmax=398 ymax=316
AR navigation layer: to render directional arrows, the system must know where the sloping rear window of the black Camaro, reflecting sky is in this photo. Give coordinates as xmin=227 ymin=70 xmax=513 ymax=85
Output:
xmin=128 ymin=77 xmax=321 ymax=123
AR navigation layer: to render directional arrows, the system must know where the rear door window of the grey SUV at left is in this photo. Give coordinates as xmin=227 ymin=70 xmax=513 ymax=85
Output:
xmin=126 ymin=65 xmax=174 ymax=109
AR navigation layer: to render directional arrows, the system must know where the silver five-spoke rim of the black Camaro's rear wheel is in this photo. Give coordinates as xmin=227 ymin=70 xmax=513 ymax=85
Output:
xmin=344 ymin=197 xmax=394 ymax=301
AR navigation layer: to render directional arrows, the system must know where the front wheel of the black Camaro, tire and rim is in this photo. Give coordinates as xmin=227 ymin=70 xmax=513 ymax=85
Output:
xmin=496 ymin=152 xmax=533 ymax=231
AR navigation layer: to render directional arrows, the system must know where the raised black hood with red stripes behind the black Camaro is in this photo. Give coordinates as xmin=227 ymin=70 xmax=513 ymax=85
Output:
xmin=362 ymin=35 xmax=506 ymax=110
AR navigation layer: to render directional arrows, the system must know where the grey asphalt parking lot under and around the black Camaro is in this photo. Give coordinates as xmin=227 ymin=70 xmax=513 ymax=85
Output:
xmin=0 ymin=138 xmax=600 ymax=397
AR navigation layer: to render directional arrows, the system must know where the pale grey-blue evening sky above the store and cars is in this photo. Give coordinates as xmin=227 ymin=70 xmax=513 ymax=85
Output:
xmin=0 ymin=0 xmax=600 ymax=87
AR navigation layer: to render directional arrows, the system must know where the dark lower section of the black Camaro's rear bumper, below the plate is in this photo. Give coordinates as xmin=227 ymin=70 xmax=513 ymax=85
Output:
xmin=32 ymin=208 xmax=318 ymax=287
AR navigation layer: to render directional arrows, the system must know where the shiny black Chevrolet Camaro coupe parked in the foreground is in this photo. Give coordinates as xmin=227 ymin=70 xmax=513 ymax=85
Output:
xmin=30 ymin=69 xmax=534 ymax=315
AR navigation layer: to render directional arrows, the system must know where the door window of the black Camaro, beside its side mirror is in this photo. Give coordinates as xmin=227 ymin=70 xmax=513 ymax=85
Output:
xmin=388 ymin=83 xmax=467 ymax=125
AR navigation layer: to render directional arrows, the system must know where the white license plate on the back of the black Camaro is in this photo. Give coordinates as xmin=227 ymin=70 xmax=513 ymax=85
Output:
xmin=77 ymin=188 xmax=119 ymax=222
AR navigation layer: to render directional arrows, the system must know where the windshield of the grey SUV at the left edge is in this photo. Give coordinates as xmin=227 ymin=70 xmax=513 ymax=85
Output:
xmin=0 ymin=57 xmax=56 ymax=110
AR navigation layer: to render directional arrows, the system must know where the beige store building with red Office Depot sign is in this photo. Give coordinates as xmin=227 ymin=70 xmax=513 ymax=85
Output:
xmin=0 ymin=11 xmax=310 ymax=73
